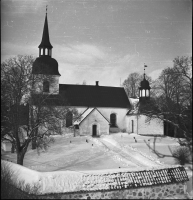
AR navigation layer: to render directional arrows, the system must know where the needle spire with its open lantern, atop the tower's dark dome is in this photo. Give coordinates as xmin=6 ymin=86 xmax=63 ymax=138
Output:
xmin=38 ymin=6 xmax=53 ymax=56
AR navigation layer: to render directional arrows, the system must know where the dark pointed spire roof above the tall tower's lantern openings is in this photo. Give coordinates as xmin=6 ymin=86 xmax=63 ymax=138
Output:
xmin=38 ymin=13 xmax=53 ymax=49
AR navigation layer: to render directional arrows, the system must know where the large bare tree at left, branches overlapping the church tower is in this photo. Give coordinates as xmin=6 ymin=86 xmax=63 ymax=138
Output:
xmin=1 ymin=55 xmax=78 ymax=165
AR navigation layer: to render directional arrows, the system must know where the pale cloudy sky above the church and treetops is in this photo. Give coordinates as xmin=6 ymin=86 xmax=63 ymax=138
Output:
xmin=1 ymin=0 xmax=192 ymax=87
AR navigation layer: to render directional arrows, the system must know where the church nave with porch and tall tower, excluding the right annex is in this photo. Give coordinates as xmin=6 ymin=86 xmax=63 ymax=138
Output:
xmin=32 ymin=10 xmax=131 ymax=136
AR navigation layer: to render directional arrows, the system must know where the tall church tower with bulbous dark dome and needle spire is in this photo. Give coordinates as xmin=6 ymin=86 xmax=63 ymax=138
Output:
xmin=32 ymin=6 xmax=61 ymax=94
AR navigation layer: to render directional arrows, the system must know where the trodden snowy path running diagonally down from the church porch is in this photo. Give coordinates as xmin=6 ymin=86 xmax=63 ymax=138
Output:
xmin=99 ymin=137 xmax=164 ymax=168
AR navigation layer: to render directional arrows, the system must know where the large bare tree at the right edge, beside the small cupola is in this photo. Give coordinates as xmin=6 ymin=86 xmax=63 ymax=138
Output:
xmin=139 ymin=57 xmax=192 ymax=162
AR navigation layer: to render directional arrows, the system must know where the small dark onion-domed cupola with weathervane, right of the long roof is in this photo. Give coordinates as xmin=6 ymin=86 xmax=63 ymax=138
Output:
xmin=139 ymin=65 xmax=151 ymax=102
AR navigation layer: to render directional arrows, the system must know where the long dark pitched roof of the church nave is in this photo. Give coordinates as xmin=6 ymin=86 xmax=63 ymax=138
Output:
xmin=34 ymin=84 xmax=130 ymax=108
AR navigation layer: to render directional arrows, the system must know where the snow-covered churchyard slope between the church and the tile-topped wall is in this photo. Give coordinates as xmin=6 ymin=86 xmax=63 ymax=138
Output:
xmin=1 ymin=133 xmax=192 ymax=197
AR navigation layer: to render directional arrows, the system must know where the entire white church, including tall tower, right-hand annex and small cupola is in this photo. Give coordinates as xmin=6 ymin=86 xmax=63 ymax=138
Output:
xmin=32 ymin=13 xmax=163 ymax=136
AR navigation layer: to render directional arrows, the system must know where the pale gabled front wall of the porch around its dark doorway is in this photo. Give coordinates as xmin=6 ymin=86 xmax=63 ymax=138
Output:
xmin=79 ymin=110 xmax=109 ymax=135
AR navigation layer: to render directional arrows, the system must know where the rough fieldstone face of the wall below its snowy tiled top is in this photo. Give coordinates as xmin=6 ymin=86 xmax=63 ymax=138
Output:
xmin=40 ymin=183 xmax=185 ymax=199
